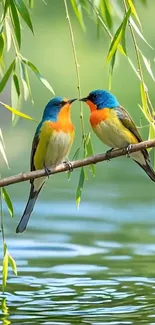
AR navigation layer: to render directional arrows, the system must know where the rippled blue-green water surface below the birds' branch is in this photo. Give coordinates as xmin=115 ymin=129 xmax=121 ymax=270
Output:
xmin=1 ymin=162 xmax=155 ymax=325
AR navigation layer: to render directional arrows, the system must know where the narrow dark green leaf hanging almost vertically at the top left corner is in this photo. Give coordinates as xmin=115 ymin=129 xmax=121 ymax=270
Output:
xmin=10 ymin=1 xmax=21 ymax=48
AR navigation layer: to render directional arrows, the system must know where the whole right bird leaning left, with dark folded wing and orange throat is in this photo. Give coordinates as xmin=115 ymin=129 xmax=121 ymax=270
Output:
xmin=80 ymin=90 xmax=155 ymax=182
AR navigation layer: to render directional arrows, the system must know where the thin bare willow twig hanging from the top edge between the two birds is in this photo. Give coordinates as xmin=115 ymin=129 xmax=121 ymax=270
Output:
xmin=64 ymin=0 xmax=85 ymax=138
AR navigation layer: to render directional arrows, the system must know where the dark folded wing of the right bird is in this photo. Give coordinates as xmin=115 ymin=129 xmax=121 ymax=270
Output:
xmin=116 ymin=106 xmax=149 ymax=160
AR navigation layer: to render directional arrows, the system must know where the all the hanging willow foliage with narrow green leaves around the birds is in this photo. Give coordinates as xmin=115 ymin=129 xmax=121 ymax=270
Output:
xmin=0 ymin=0 xmax=155 ymax=290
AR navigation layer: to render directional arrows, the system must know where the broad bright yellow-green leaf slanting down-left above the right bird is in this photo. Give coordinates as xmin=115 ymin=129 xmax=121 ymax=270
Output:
xmin=106 ymin=8 xmax=131 ymax=63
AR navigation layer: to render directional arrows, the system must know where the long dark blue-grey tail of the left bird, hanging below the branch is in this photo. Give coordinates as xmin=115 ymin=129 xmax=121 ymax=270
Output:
xmin=16 ymin=183 xmax=44 ymax=233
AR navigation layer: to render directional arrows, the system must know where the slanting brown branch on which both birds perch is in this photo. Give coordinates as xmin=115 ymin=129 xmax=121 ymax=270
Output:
xmin=0 ymin=139 xmax=155 ymax=187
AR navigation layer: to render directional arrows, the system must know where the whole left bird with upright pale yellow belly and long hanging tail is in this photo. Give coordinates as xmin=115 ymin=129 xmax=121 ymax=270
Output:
xmin=16 ymin=97 xmax=76 ymax=233
